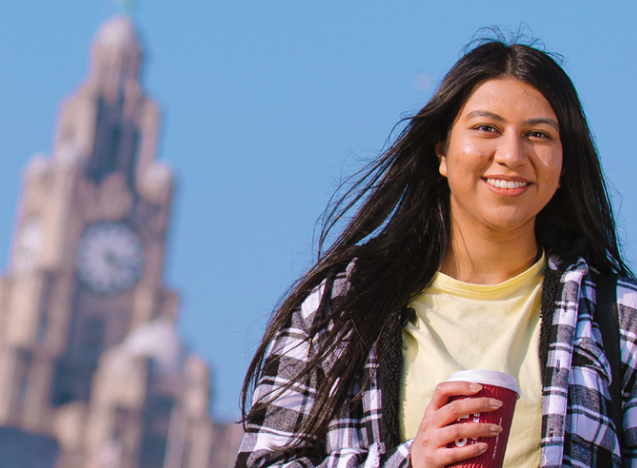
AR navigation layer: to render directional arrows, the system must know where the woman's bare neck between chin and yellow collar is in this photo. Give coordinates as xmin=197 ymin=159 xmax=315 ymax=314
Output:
xmin=440 ymin=217 xmax=538 ymax=284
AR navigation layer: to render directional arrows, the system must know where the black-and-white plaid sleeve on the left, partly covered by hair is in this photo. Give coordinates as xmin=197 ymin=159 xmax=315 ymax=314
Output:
xmin=235 ymin=280 xmax=412 ymax=468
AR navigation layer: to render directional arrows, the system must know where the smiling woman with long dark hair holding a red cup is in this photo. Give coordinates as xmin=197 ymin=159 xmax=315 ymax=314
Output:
xmin=237 ymin=41 xmax=637 ymax=468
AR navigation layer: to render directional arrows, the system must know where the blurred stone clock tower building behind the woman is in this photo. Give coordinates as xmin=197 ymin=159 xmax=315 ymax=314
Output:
xmin=0 ymin=17 xmax=241 ymax=468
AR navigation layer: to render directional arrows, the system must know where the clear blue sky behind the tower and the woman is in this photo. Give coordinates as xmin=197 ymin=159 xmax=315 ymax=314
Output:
xmin=0 ymin=0 xmax=637 ymax=419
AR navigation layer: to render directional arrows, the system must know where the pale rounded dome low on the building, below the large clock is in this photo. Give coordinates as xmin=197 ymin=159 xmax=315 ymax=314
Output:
xmin=118 ymin=318 xmax=187 ymax=374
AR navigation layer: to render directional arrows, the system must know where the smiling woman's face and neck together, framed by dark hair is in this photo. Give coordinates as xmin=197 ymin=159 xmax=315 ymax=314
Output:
xmin=436 ymin=78 xmax=562 ymax=284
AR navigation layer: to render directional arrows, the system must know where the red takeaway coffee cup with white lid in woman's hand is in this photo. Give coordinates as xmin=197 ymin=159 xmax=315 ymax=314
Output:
xmin=447 ymin=369 xmax=520 ymax=468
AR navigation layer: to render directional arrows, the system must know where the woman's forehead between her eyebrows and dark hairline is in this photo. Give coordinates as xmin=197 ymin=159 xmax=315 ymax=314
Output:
xmin=458 ymin=78 xmax=557 ymax=120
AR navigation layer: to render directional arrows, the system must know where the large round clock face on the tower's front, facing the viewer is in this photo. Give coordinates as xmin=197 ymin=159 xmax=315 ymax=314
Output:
xmin=75 ymin=221 xmax=144 ymax=295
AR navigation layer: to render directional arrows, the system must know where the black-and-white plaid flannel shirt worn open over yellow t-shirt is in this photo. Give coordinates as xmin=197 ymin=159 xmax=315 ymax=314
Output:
xmin=236 ymin=256 xmax=637 ymax=468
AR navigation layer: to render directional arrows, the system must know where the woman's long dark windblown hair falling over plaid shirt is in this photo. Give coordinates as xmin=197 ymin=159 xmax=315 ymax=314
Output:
xmin=242 ymin=40 xmax=632 ymax=447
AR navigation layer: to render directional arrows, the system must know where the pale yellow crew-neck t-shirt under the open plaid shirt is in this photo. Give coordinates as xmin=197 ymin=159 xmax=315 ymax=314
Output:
xmin=399 ymin=255 xmax=546 ymax=468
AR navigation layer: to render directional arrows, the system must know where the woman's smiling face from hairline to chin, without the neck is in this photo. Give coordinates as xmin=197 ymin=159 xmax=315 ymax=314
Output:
xmin=436 ymin=78 xmax=562 ymax=238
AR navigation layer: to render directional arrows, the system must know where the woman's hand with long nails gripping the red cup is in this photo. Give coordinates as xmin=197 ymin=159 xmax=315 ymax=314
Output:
xmin=410 ymin=382 xmax=502 ymax=468
